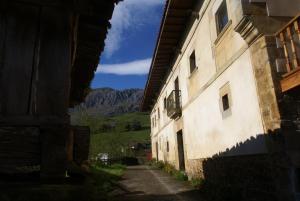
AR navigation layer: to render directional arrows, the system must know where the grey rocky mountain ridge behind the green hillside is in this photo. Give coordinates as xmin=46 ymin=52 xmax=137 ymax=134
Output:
xmin=75 ymin=88 xmax=144 ymax=116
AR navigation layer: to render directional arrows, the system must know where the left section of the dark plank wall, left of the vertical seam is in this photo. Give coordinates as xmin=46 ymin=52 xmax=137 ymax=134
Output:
xmin=0 ymin=6 xmax=39 ymax=115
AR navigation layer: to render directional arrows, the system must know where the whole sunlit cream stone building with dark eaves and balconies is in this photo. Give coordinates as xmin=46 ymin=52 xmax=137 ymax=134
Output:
xmin=141 ymin=0 xmax=300 ymax=200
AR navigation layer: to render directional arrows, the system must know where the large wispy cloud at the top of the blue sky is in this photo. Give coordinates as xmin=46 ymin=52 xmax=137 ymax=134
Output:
xmin=104 ymin=0 xmax=165 ymax=58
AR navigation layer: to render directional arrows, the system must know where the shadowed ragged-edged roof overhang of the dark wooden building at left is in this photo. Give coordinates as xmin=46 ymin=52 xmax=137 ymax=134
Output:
xmin=70 ymin=0 xmax=120 ymax=107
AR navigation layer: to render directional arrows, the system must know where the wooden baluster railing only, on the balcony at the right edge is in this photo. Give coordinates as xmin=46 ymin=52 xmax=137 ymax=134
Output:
xmin=276 ymin=15 xmax=300 ymax=73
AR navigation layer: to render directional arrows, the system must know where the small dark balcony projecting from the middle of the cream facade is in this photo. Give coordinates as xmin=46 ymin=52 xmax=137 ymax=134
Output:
xmin=167 ymin=90 xmax=181 ymax=119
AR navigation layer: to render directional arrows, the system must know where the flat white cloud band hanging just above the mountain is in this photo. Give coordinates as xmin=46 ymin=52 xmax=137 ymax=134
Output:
xmin=96 ymin=58 xmax=151 ymax=75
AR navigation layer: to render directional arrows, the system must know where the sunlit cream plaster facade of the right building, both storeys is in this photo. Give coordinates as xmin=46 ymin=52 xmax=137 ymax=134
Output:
xmin=152 ymin=0 xmax=265 ymax=163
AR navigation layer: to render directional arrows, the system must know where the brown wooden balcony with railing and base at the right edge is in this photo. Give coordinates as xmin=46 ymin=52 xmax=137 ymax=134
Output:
xmin=276 ymin=15 xmax=300 ymax=92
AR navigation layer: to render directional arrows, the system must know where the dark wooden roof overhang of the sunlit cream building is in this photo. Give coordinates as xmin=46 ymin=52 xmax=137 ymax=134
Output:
xmin=141 ymin=0 xmax=201 ymax=111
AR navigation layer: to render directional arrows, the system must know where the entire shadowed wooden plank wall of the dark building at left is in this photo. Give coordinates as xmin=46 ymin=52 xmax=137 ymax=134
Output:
xmin=0 ymin=4 xmax=72 ymax=117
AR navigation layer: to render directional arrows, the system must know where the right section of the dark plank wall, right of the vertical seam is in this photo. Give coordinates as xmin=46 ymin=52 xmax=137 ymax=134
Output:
xmin=35 ymin=8 xmax=72 ymax=116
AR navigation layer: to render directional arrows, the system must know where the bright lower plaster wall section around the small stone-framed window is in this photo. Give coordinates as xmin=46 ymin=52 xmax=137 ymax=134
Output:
xmin=183 ymin=51 xmax=265 ymax=159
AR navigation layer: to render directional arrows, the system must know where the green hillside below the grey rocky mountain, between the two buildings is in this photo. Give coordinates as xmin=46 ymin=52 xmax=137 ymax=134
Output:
xmin=72 ymin=112 xmax=150 ymax=157
